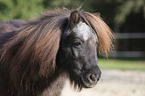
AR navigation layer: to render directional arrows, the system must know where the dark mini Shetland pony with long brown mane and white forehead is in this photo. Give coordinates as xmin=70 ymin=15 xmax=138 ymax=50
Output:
xmin=0 ymin=9 xmax=113 ymax=96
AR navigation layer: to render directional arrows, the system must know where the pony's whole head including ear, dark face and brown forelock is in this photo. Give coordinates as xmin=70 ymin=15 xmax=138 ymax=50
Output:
xmin=56 ymin=10 xmax=113 ymax=88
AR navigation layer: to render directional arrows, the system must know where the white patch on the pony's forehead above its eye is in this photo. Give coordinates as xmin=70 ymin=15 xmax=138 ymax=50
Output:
xmin=73 ymin=21 xmax=97 ymax=41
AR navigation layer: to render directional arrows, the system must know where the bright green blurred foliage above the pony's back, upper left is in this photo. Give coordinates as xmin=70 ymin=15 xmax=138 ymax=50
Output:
xmin=0 ymin=0 xmax=43 ymax=21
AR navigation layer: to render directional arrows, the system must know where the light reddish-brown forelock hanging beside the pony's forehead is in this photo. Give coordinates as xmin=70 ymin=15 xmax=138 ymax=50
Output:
xmin=82 ymin=12 xmax=114 ymax=56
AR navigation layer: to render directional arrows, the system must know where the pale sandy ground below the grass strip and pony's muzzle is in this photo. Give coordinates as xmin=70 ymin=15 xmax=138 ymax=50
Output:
xmin=61 ymin=70 xmax=145 ymax=96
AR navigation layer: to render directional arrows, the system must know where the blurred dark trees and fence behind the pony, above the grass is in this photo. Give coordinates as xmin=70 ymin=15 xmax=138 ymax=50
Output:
xmin=0 ymin=0 xmax=145 ymax=59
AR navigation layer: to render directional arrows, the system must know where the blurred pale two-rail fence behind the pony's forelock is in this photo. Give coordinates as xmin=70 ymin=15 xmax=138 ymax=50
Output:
xmin=110 ymin=33 xmax=145 ymax=57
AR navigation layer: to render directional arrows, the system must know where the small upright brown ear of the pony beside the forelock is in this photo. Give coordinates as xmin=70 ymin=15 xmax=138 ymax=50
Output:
xmin=70 ymin=10 xmax=80 ymax=28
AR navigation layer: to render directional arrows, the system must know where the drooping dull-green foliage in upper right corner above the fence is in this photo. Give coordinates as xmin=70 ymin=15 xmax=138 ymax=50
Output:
xmin=115 ymin=0 xmax=145 ymax=24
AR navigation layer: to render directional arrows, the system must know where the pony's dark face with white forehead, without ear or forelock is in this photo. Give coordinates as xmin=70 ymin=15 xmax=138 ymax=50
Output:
xmin=56 ymin=10 xmax=101 ymax=88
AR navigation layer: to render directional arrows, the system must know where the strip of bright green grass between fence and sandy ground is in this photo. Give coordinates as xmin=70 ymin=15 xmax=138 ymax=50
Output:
xmin=98 ymin=59 xmax=145 ymax=70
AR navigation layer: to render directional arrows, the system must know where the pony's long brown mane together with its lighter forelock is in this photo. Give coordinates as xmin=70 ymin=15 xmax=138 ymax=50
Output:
xmin=0 ymin=9 xmax=113 ymax=92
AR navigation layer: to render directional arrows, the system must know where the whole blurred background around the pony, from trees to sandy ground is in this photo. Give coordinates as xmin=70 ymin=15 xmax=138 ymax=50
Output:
xmin=0 ymin=0 xmax=145 ymax=96
